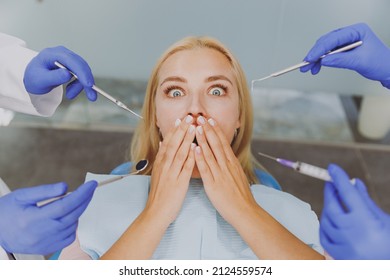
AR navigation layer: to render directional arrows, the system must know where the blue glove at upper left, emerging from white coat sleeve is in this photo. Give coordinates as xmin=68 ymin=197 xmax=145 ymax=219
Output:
xmin=23 ymin=46 xmax=97 ymax=101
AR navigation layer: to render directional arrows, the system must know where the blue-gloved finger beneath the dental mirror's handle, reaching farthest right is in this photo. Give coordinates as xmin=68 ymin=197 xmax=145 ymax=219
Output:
xmin=41 ymin=181 xmax=97 ymax=219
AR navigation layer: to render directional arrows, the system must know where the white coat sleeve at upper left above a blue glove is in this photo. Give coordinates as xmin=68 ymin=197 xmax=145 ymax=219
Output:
xmin=0 ymin=33 xmax=63 ymax=116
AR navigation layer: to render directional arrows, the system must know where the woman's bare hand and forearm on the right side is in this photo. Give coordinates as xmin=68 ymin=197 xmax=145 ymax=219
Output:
xmin=195 ymin=117 xmax=324 ymax=259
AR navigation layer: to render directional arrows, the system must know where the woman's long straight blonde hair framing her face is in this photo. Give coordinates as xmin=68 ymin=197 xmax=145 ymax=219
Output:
xmin=130 ymin=37 xmax=264 ymax=184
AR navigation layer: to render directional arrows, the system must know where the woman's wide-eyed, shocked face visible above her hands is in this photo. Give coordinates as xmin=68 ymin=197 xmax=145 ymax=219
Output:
xmin=155 ymin=48 xmax=240 ymax=142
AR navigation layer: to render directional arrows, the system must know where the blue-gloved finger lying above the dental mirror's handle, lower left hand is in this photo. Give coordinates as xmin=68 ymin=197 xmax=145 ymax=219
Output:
xmin=14 ymin=182 xmax=68 ymax=204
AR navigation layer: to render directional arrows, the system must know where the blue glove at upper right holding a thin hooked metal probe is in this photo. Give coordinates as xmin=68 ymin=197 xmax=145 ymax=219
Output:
xmin=301 ymin=23 xmax=390 ymax=88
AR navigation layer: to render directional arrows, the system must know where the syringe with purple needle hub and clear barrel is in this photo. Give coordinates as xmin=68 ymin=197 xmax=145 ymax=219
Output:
xmin=258 ymin=153 xmax=332 ymax=182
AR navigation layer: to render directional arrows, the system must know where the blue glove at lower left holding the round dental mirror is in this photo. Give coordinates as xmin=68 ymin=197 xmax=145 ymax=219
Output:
xmin=0 ymin=181 xmax=97 ymax=255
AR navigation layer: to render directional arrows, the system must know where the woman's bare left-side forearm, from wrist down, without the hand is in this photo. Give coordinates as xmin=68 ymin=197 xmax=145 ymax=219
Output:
xmin=101 ymin=211 xmax=168 ymax=260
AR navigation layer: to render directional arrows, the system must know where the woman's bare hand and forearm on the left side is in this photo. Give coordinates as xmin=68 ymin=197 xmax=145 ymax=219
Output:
xmin=101 ymin=117 xmax=195 ymax=259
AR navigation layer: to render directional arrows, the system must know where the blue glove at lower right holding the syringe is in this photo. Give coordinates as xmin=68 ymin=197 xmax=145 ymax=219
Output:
xmin=320 ymin=164 xmax=390 ymax=259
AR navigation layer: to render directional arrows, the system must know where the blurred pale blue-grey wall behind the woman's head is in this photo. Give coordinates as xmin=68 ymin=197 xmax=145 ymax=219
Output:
xmin=0 ymin=0 xmax=390 ymax=94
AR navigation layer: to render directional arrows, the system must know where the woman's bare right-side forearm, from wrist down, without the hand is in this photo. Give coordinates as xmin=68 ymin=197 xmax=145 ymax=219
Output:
xmin=232 ymin=203 xmax=324 ymax=260
